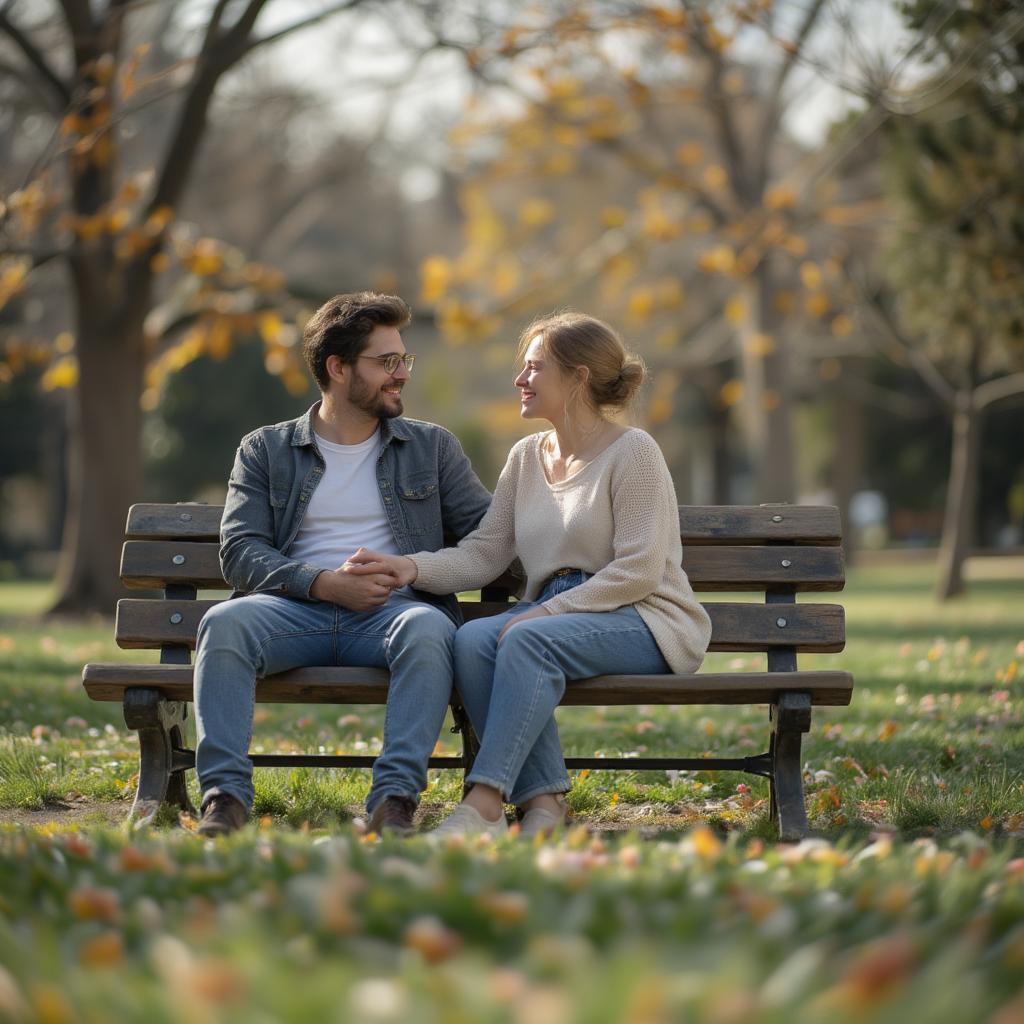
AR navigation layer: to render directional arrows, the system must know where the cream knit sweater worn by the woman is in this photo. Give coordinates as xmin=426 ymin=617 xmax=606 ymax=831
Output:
xmin=412 ymin=428 xmax=711 ymax=673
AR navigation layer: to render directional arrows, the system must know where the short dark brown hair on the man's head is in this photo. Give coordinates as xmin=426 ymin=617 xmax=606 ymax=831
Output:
xmin=302 ymin=292 xmax=413 ymax=391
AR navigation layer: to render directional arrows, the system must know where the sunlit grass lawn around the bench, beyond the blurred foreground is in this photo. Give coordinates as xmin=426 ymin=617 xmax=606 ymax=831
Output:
xmin=0 ymin=558 xmax=1024 ymax=840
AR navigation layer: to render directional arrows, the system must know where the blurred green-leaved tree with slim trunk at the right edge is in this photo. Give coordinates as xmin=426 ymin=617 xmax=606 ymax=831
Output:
xmin=869 ymin=0 xmax=1024 ymax=600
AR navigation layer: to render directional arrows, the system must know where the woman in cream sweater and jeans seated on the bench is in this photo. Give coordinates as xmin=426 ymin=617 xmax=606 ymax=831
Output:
xmin=356 ymin=312 xmax=711 ymax=836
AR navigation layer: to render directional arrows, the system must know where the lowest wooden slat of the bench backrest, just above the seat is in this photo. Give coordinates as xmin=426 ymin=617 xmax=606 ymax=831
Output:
xmin=115 ymin=598 xmax=846 ymax=653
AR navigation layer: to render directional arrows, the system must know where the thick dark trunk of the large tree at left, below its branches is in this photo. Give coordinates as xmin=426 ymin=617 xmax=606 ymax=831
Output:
xmin=50 ymin=282 xmax=145 ymax=614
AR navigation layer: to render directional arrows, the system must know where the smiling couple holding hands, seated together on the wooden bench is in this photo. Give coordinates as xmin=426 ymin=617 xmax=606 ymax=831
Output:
xmin=195 ymin=292 xmax=711 ymax=837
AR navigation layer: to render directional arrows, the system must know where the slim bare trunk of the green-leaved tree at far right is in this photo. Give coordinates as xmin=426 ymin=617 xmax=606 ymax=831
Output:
xmin=935 ymin=390 xmax=982 ymax=601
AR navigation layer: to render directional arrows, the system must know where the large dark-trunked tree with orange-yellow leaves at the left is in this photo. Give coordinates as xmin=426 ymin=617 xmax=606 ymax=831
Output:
xmin=0 ymin=0 xmax=391 ymax=611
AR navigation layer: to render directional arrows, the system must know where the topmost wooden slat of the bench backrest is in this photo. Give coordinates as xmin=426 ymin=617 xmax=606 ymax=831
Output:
xmin=125 ymin=503 xmax=842 ymax=546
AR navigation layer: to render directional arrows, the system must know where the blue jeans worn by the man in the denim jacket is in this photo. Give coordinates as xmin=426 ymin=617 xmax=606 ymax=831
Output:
xmin=195 ymin=593 xmax=456 ymax=813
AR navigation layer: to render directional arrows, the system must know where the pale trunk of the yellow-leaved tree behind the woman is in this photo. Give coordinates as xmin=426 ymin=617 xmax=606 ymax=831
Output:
xmin=739 ymin=262 xmax=797 ymax=502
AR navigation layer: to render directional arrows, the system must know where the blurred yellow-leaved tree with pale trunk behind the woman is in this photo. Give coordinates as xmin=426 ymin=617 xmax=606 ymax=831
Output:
xmin=415 ymin=0 xmax=880 ymax=501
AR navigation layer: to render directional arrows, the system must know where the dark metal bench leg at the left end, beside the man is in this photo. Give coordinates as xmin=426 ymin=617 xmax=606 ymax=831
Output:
xmin=124 ymin=687 xmax=196 ymax=828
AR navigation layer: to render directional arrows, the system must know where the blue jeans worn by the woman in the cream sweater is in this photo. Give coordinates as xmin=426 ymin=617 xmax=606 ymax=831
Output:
xmin=455 ymin=570 xmax=671 ymax=804
